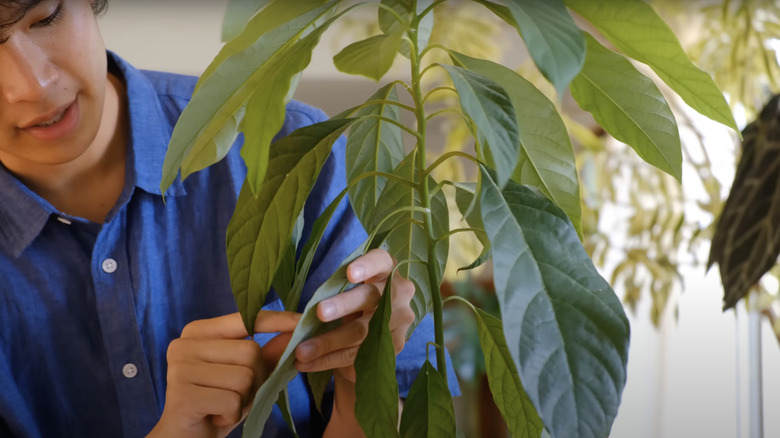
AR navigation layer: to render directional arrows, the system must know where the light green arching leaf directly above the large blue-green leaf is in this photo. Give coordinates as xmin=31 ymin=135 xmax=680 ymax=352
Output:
xmin=450 ymin=52 xmax=582 ymax=237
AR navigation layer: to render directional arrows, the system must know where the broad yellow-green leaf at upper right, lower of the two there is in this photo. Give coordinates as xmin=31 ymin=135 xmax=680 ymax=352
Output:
xmin=571 ymin=35 xmax=682 ymax=181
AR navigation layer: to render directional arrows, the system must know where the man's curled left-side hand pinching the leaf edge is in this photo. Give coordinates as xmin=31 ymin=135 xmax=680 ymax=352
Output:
xmin=148 ymin=311 xmax=300 ymax=438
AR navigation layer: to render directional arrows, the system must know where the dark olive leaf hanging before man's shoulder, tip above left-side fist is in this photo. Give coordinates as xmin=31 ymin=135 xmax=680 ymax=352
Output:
xmin=227 ymin=119 xmax=351 ymax=333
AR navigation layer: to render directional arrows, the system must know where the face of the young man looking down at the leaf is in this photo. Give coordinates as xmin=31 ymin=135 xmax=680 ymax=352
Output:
xmin=0 ymin=0 xmax=106 ymax=170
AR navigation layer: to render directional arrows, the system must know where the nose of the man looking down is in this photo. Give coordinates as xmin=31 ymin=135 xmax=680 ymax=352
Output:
xmin=0 ymin=35 xmax=59 ymax=104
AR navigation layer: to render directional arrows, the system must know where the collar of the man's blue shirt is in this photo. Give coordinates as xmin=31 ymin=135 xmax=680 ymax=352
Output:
xmin=0 ymin=51 xmax=186 ymax=257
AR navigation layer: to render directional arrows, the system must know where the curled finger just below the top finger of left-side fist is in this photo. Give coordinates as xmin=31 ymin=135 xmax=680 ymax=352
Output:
xmin=167 ymin=338 xmax=262 ymax=367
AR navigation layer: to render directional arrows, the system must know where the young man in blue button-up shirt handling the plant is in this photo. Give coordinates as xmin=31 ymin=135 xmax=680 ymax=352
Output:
xmin=0 ymin=0 xmax=455 ymax=437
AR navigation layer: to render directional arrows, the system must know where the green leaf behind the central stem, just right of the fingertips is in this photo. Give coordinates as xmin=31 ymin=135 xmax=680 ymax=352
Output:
xmin=368 ymin=153 xmax=449 ymax=326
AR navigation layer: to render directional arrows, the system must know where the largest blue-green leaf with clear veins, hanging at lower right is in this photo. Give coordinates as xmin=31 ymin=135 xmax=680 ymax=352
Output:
xmin=480 ymin=167 xmax=629 ymax=438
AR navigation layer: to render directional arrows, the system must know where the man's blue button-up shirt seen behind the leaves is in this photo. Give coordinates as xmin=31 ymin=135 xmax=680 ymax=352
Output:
xmin=0 ymin=52 xmax=458 ymax=438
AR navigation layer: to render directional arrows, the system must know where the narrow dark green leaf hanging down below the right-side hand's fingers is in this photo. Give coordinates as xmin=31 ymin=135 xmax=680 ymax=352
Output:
xmin=355 ymin=276 xmax=398 ymax=437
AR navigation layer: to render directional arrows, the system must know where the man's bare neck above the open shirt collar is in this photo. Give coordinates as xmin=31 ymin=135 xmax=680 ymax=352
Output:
xmin=8 ymin=75 xmax=127 ymax=223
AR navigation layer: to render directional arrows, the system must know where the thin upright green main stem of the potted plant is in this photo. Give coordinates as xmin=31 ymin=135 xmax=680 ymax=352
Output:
xmin=409 ymin=14 xmax=447 ymax=384
